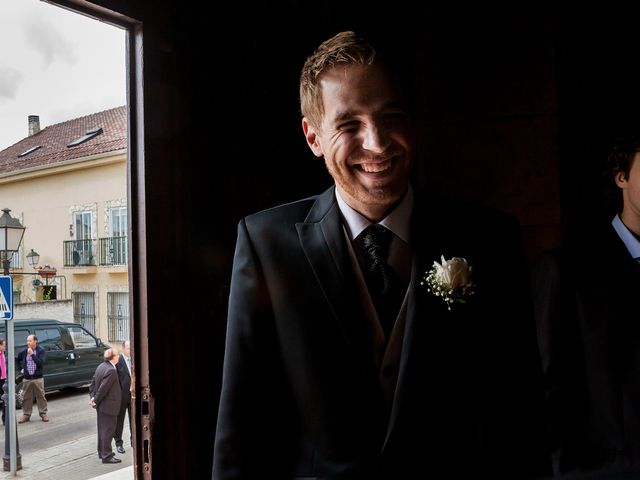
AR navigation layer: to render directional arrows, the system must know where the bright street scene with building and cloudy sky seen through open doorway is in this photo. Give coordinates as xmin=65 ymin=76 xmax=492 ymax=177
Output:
xmin=0 ymin=0 xmax=135 ymax=480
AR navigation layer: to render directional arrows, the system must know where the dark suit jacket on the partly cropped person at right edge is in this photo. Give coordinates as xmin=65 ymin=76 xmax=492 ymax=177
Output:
xmin=533 ymin=225 xmax=640 ymax=478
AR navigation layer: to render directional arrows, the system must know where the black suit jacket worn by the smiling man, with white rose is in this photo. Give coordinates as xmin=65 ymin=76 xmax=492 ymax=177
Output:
xmin=213 ymin=188 xmax=546 ymax=480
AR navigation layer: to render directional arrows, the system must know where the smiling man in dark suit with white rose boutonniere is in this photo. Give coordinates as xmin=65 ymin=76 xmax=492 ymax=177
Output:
xmin=213 ymin=32 xmax=547 ymax=480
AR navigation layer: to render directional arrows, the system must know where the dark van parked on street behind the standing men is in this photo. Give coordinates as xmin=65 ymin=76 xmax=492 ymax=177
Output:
xmin=0 ymin=319 xmax=109 ymax=408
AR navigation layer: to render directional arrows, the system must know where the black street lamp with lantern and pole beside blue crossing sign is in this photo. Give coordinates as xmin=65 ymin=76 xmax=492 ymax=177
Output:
xmin=0 ymin=208 xmax=25 ymax=473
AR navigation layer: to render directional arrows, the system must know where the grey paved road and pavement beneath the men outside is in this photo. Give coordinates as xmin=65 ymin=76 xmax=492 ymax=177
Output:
xmin=0 ymin=387 xmax=133 ymax=480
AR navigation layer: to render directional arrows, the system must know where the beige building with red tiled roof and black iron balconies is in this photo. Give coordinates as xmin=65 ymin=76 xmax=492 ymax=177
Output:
xmin=0 ymin=106 xmax=129 ymax=343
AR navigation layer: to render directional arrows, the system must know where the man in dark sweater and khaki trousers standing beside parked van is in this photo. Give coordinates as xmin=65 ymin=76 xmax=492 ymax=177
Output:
xmin=16 ymin=335 xmax=49 ymax=423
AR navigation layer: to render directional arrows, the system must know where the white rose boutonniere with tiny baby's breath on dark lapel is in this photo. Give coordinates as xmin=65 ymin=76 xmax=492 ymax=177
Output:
xmin=420 ymin=255 xmax=475 ymax=310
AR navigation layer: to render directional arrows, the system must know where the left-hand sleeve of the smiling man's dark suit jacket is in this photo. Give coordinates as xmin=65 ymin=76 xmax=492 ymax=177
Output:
xmin=213 ymin=220 xmax=292 ymax=480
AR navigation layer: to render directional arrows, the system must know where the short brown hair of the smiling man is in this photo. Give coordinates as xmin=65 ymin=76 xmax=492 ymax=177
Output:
xmin=300 ymin=31 xmax=377 ymax=128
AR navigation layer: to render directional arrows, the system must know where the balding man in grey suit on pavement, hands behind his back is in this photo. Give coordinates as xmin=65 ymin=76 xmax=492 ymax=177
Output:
xmin=89 ymin=348 xmax=122 ymax=463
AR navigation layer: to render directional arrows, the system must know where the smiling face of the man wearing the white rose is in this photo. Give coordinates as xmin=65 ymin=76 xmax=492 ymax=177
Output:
xmin=303 ymin=65 xmax=412 ymax=216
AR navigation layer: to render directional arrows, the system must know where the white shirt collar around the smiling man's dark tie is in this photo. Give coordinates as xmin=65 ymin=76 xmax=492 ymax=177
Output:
xmin=335 ymin=185 xmax=413 ymax=244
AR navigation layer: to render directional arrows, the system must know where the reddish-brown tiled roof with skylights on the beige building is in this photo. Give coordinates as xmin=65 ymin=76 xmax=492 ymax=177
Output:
xmin=0 ymin=106 xmax=127 ymax=174
